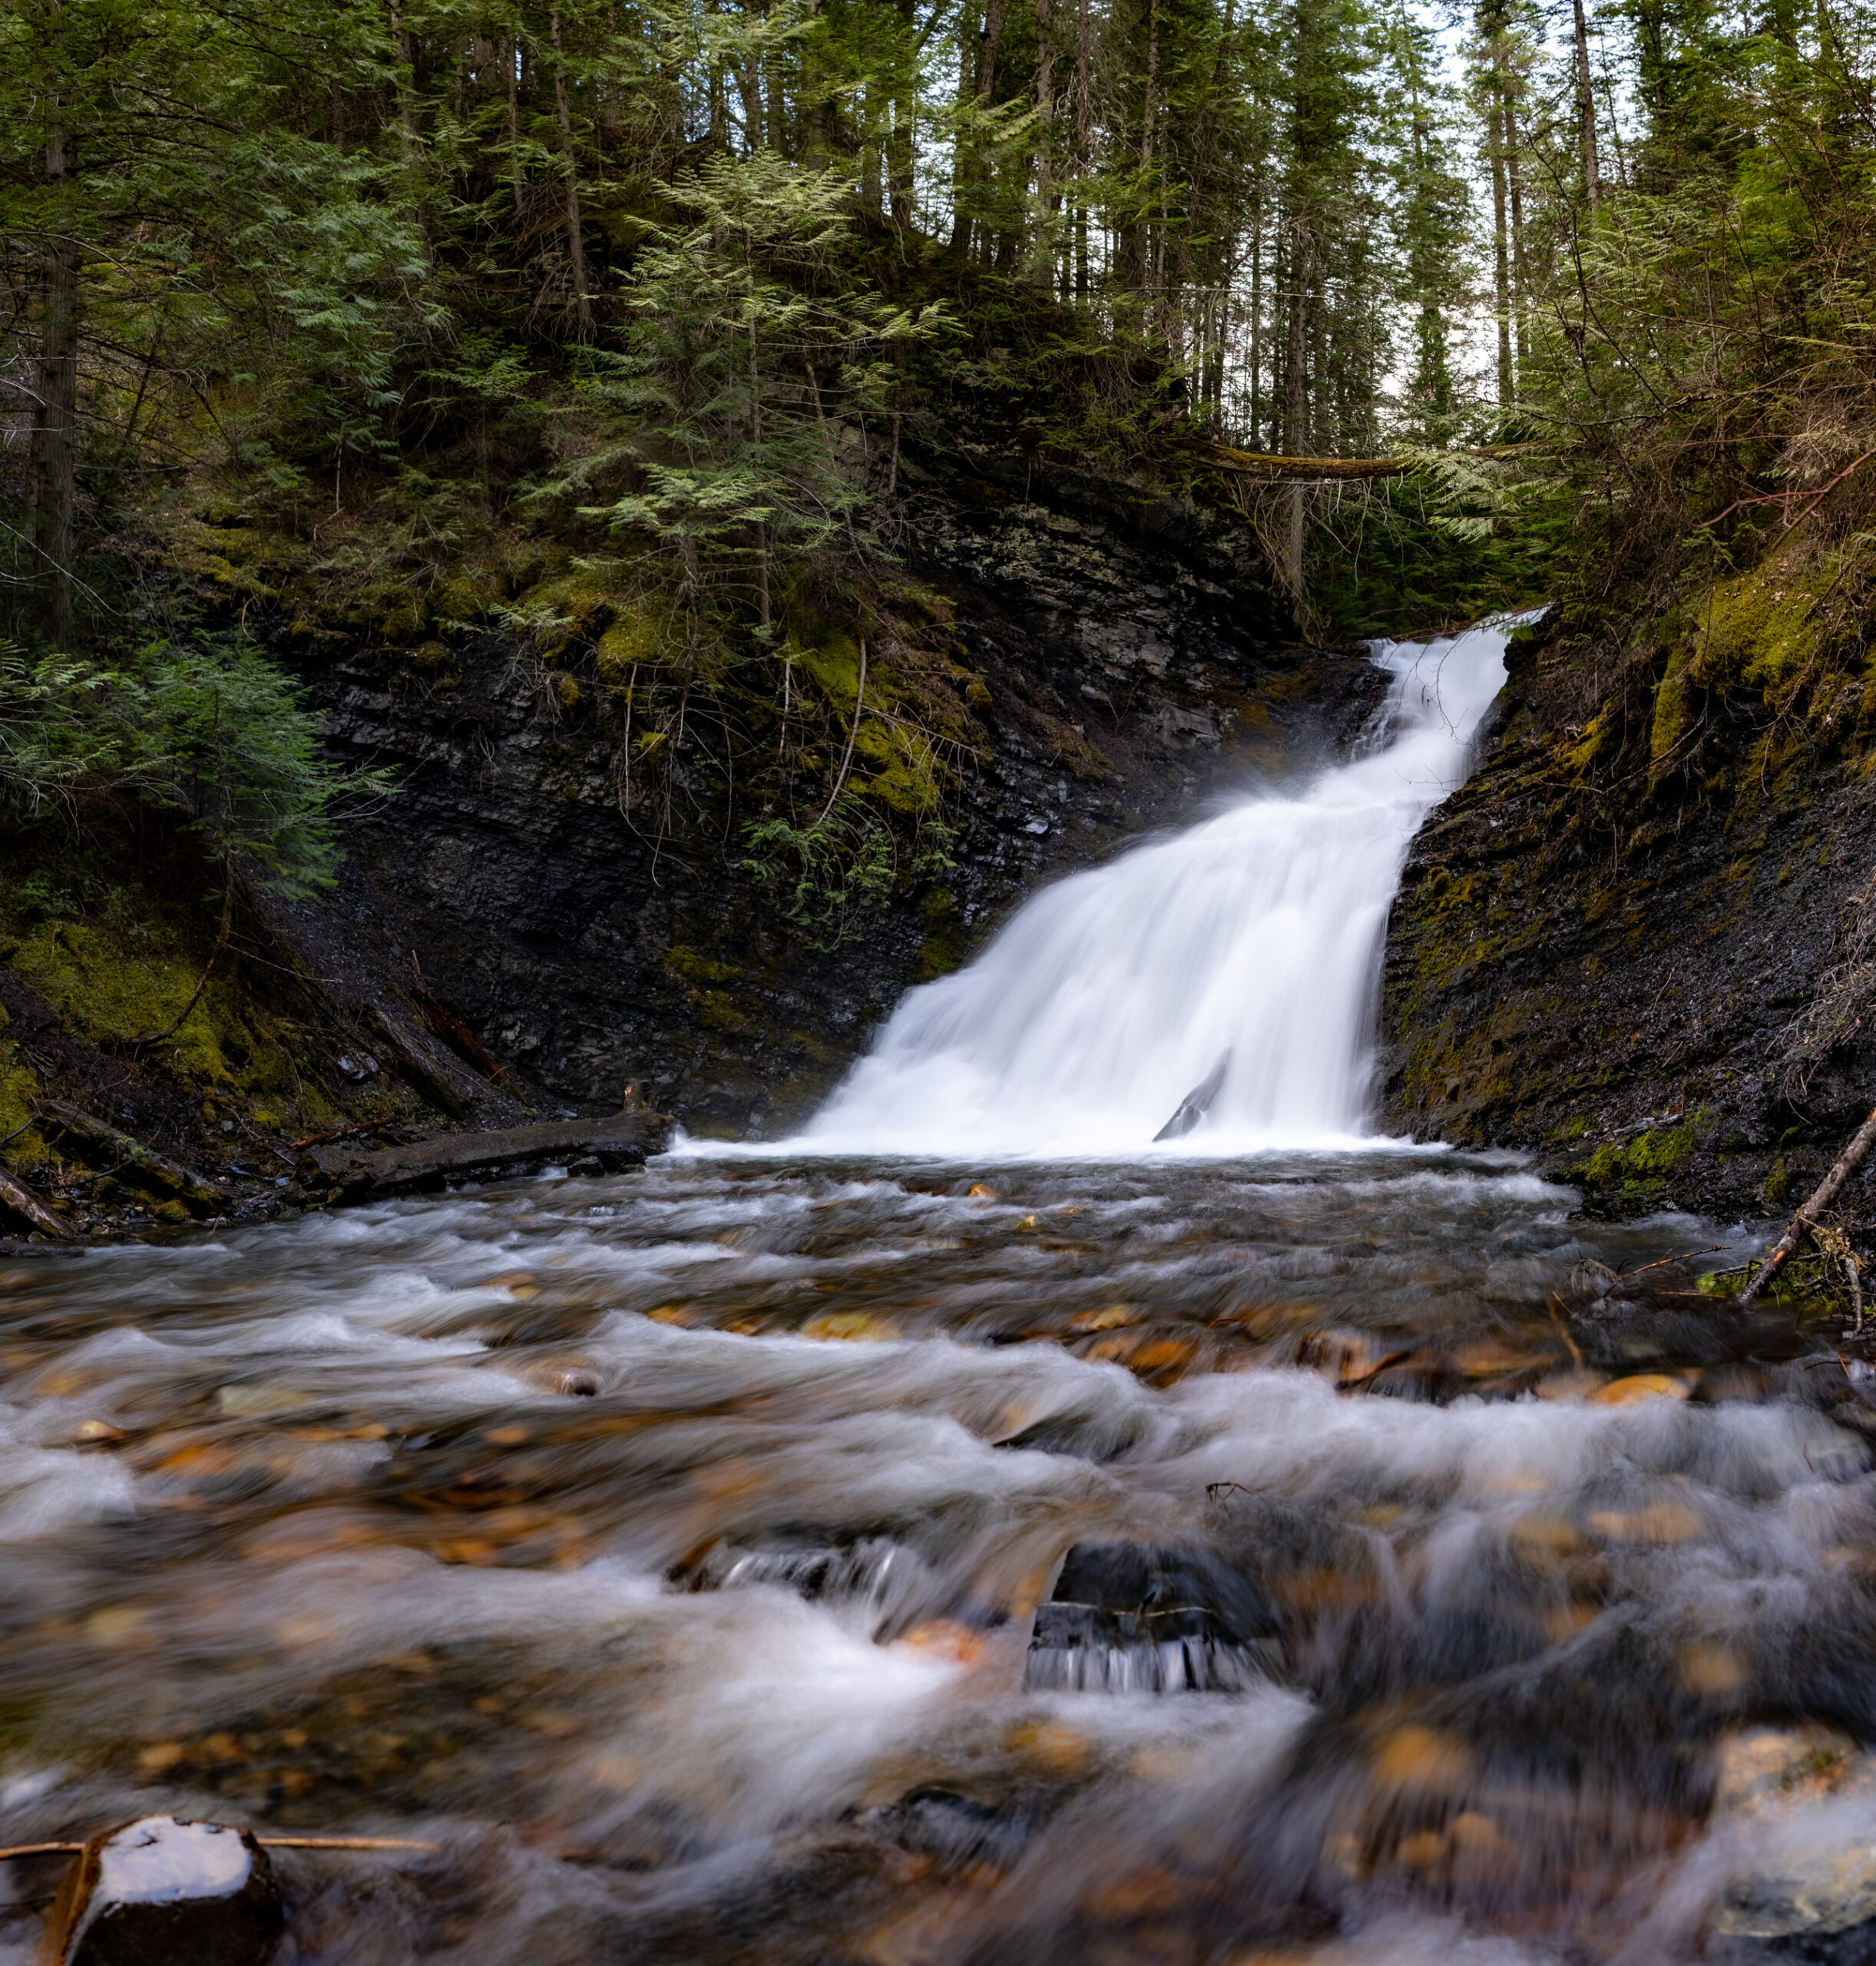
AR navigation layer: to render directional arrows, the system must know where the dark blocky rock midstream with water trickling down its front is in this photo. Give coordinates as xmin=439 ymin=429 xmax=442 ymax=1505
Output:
xmin=1023 ymin=1544 xmax=1276 ymax=1693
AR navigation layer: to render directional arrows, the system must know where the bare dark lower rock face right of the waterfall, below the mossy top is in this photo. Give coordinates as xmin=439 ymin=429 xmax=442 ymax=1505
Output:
xmin=1382 ymin=629 xmax=1876 ymax=1219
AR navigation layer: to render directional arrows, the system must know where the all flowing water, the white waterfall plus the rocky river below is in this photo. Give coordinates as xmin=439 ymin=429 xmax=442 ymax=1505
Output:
xmin=0 ymin=637 xmax=1876 ymax=1966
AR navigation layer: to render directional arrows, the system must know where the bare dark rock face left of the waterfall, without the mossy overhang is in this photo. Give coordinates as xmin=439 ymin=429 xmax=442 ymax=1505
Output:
xmin=293 ymin=458 xmax=1382 ymax=1134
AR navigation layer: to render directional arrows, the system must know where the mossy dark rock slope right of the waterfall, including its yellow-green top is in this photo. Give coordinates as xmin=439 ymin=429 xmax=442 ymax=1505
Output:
xmin=1382 ymin=541 xmax=1876 ymax=1215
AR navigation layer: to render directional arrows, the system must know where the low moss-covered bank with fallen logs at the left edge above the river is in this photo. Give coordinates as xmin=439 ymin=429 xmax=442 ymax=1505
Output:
xmin=0 ymin=826 xmax=517 ymax=1236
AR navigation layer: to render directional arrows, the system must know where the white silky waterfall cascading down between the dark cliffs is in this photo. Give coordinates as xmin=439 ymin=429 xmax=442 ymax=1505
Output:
xmin=795 ymin=621 xmax=1514 ymax=1154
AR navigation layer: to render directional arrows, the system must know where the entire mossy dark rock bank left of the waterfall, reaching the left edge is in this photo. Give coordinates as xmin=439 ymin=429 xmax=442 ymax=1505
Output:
xmin=0 ymin=440 xmax=1381 ymax=1233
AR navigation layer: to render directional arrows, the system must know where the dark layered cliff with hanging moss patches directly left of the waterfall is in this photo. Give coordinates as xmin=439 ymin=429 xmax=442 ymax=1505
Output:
xmin=276 ymin=458 xmax=1377 ymax=1133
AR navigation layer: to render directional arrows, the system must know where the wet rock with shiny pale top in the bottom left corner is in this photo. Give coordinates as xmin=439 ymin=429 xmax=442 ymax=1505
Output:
xmin=39 ymin=1816 xmax=283 ymax=1966
